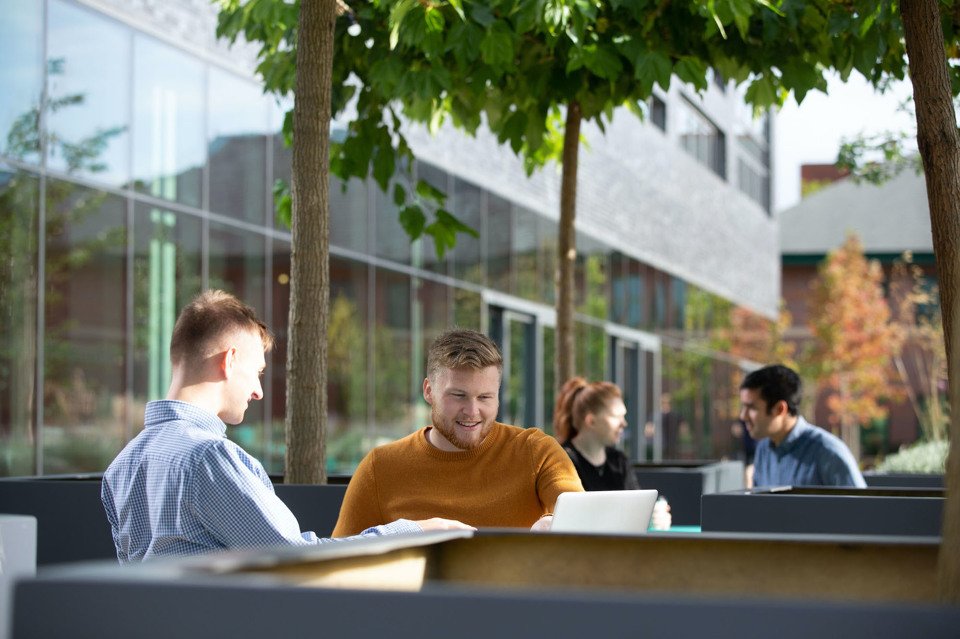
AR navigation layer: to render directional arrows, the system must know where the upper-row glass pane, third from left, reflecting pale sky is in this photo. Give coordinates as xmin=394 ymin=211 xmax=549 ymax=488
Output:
xmin=133 ymin=35 xmax=206 ymax=206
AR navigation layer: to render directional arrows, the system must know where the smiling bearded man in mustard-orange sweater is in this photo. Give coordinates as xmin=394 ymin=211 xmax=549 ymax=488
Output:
xmin=333 ymin=330 xmax=583 ymax=537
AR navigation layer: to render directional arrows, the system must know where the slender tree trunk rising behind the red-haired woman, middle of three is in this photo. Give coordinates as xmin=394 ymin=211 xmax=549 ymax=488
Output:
xmin=555 ymin=102 xmax=580 ymax=388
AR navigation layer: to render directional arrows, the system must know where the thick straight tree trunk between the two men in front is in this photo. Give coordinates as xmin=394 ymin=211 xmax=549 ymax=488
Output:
xmin=286 ymin=0 xmax=336 ymax=484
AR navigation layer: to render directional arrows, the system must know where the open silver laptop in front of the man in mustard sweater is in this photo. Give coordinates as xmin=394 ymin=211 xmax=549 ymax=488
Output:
xmin=550 ymin=490 xmax=657 ymax=535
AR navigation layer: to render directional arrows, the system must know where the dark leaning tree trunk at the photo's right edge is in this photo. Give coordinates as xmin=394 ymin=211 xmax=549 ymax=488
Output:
xmin=900 ymin=0 xmax=960 ymax=603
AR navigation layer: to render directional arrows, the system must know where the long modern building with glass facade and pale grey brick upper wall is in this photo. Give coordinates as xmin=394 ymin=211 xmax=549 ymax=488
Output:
xmin=0 ymin=0 xmax=780 ymax=475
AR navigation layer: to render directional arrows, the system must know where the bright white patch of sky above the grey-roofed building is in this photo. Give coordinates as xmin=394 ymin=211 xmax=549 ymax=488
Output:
xmin=773 ymin=73 xmax=916 ymax=211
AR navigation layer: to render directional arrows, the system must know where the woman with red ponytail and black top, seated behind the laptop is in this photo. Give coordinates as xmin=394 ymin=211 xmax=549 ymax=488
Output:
xmin=553 ymin=377 xmax=671 ymax=529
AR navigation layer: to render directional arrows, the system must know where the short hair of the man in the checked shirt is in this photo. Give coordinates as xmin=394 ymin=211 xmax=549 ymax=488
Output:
xmin=170 ymin=290 xmax=273 ymax=364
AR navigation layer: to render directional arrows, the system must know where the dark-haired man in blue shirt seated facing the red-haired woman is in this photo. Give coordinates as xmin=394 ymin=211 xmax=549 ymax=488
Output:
xmin=740 ymin=365 xmax=867 ymax=488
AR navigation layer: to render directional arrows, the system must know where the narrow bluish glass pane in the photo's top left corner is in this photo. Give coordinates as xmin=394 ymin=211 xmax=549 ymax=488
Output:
xmin=0 ymin=0 xmax=43 ymax=164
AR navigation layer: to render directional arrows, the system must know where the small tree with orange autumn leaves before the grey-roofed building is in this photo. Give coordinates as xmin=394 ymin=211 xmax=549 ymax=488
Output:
xmin=806 ymin=233 xmax=902 ymax=458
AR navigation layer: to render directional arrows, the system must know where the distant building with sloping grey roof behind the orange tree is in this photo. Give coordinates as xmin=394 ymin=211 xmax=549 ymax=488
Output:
xmin=780 ymin=165 xmax=939 ymax=454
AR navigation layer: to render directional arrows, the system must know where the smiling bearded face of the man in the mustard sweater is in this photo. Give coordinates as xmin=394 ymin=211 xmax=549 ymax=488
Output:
xmin=423 ymin=366 xmax=500 ymax=450
